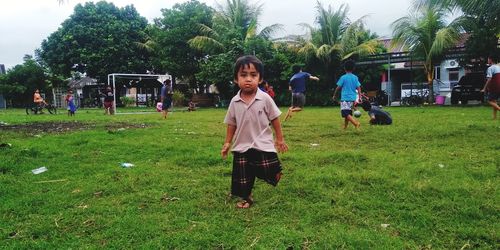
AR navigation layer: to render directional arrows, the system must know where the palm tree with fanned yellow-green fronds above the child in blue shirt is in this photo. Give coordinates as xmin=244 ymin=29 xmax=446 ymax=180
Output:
xmin=299 ymin=1 xmax=380 ymax=80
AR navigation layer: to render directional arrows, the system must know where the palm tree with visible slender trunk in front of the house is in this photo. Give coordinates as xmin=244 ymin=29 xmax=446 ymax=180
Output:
xmin=392 ymin=3 xmax=461 ymax=102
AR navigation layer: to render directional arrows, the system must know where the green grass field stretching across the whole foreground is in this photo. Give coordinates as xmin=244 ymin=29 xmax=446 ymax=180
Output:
xmin=0 ymin=106 xmax=500 ymax=249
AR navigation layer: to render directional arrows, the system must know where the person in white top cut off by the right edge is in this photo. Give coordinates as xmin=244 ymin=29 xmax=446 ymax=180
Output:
xmin=481 ymin=54 xmax=500 ymax=120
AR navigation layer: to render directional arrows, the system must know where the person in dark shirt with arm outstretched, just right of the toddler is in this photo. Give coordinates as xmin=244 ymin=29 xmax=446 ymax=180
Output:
xmin=285 ymin=65 xmax=319 ymax=121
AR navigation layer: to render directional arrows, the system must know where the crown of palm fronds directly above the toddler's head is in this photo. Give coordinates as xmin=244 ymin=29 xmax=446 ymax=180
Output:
xmin=189 ymin=0 xmax=282 ymax=54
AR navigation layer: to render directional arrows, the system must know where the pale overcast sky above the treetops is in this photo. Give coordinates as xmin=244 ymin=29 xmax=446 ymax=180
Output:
xmin=0 ymin=0 xmax=411 ymax=68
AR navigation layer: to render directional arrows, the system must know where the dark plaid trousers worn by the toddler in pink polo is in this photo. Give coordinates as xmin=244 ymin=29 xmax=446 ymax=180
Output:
xmin=231 ymin=149 xmax=281 ymax=199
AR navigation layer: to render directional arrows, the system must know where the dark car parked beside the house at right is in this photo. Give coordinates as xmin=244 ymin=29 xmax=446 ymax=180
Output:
xmin=451 ymin=72 xmax=486 ymax=104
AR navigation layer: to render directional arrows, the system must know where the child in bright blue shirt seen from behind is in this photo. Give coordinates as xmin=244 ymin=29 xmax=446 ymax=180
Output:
xmin=333 ymin=60 xmax=361 ymax=129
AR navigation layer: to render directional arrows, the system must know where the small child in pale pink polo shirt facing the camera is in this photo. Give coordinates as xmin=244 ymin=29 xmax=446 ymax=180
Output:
xmin=221 ymin=56 xmax=288 ymax=208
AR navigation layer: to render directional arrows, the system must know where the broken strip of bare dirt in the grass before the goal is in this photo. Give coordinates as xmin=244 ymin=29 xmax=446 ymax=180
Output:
xmin=0 ymin=121 xmax=147 ymax=135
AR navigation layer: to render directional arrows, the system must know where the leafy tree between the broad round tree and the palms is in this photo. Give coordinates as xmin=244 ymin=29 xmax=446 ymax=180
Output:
xmin=150 ymin=0 xmax=213 ymax=90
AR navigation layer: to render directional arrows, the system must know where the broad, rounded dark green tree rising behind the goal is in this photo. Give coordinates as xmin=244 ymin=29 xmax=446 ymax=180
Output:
xmin=38 ymin=1 xmax=150 ymax=81
